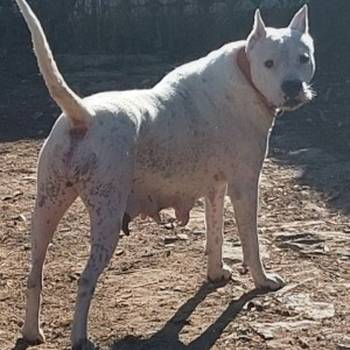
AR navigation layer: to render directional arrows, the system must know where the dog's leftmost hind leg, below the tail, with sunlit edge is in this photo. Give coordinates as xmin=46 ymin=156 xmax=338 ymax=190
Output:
xmin=22 ymin=170 xmax=77 ymax=345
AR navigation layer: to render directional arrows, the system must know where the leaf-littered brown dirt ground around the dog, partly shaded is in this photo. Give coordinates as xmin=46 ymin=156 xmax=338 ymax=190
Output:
xmin=0 ymin=58 xmax=350 ymax=350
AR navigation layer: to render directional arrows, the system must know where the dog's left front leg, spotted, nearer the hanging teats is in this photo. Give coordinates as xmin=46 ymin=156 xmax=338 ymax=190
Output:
xmin=205 ymin=183 xmax=231 ymax=282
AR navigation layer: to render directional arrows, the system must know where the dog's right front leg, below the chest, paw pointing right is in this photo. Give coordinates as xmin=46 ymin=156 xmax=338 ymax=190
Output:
xmin=228 ymin=172 xmax=284 ymax=290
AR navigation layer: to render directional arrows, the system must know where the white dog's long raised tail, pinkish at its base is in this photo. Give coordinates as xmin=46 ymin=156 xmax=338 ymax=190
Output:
xmin=16 ymin=0 xmax=94 ymax=129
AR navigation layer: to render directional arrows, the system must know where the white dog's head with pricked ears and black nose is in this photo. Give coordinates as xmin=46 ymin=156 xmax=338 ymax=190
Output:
xmin=246 ymin=5 xmax=315 ymax=110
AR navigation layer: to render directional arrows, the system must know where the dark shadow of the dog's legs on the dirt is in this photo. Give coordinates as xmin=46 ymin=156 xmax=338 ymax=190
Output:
xmin=110 ymin=283 xmax=267 ymax=350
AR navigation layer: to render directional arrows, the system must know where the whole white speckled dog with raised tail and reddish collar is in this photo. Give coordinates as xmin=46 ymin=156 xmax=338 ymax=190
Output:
xmin=16 ymin=0 xmax=315 ymax=350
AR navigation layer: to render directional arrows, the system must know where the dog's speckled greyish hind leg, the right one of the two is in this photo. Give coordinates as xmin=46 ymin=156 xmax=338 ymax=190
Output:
xmin=71 ymin=185 xmax=127 ymax=350
